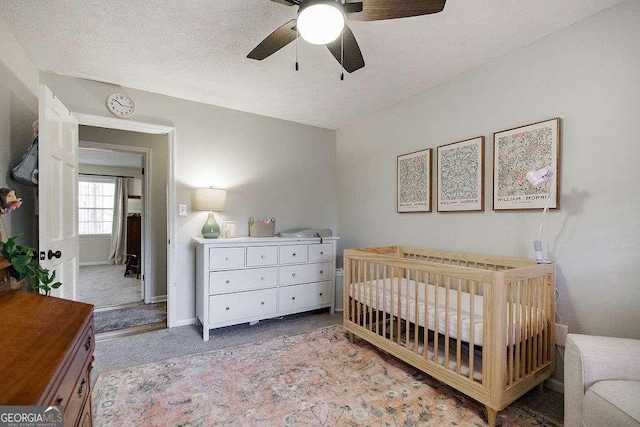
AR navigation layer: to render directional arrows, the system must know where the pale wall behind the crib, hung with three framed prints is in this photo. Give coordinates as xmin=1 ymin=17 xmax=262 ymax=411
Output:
xmin=337 ymin=1 xmax=640 ymax=344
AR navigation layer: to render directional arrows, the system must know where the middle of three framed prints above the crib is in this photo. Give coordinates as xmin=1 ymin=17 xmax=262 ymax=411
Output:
xmin=436 ymin=136 xmax=484 ymax=212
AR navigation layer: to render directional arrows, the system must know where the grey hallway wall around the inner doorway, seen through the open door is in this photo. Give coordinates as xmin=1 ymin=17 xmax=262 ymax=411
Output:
xmin=78 ymin=127 xmax=169 ymax=298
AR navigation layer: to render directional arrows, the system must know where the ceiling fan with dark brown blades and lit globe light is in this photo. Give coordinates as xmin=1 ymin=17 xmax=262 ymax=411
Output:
xmin=247 ymin=0 xmax=446 ymax=73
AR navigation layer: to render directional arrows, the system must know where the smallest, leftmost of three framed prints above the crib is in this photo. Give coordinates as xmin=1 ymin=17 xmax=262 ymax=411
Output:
xmin=396 ymin=148 xmax=431 ymax=213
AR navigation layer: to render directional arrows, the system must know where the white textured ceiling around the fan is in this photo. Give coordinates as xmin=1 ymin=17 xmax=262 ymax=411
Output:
xmin=0 ymin=0 xmax=622 ymax=129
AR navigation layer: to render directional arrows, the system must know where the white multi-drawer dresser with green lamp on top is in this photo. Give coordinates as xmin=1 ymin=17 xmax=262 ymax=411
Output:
xmin=193 ymin=237 xmax=338 ymax=341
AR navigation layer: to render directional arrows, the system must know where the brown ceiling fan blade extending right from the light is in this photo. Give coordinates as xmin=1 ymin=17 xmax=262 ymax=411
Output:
xmin=347 ymin=0 xmax=447 ymax=21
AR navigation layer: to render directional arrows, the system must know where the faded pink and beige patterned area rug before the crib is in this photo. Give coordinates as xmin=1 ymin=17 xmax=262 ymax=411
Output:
xmin=93 ymin=325 xmax=558 ymax=426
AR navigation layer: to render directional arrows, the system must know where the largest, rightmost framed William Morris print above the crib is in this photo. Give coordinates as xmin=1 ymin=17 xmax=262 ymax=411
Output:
xmin=493 ymin=118 xmax=561 ymax=210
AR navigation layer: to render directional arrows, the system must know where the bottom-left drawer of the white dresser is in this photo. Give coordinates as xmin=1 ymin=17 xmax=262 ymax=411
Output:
xmin=209 ymin=288 xmax=278 ymax=323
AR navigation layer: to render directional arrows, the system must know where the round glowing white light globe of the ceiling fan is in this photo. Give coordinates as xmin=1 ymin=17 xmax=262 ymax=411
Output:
xmin=296 ymin=0 xmax=344 ymax=45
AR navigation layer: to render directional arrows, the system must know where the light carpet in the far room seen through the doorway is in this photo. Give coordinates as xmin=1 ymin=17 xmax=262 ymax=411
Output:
xmin=78 ymin=265 xmax=142 ymax=308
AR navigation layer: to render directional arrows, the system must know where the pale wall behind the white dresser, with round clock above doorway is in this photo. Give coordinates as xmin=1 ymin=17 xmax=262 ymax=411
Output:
xmin=40 ymin=73 xmax=337 ymax=323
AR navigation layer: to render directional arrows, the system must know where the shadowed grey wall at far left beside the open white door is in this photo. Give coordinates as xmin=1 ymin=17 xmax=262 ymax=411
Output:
xmin=0 ymin=61 xmax=38 ymax=247
